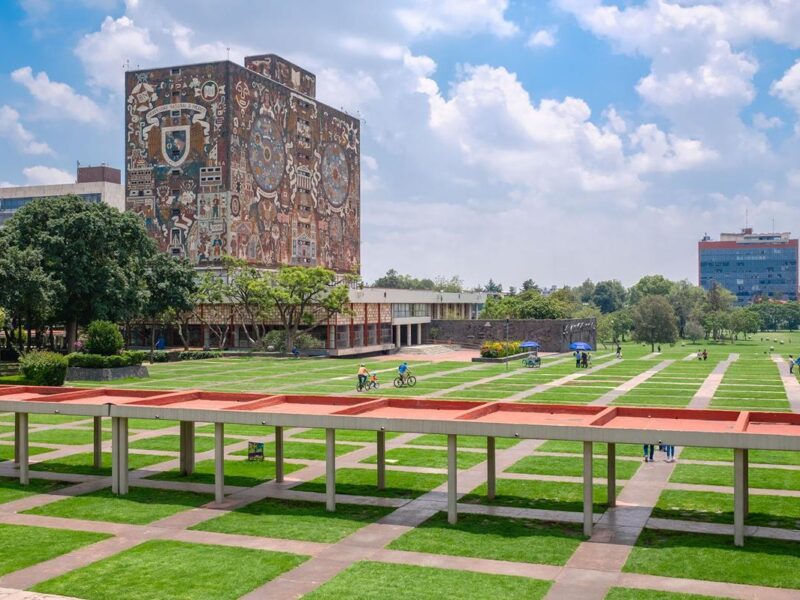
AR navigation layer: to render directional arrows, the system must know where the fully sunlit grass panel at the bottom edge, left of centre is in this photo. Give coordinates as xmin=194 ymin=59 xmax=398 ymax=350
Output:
xmin=33 ymin=540 xmax=306 ymax=600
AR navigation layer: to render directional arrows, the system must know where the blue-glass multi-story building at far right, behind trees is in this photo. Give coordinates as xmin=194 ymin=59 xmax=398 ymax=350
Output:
xmin=697 ymin=228 xmax=798 ymax=305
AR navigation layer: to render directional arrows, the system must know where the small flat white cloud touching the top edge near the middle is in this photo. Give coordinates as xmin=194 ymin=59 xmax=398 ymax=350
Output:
xmin=395 ymin=0 xmax=519 ymax=38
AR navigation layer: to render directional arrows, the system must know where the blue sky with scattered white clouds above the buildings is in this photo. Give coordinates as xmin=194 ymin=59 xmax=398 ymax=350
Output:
xmin=0 ymin=0 xmax=800 ymax=287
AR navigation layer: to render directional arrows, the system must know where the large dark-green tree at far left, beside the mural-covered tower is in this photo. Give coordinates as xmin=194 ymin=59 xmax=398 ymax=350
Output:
xmin=2 ymin=196 xmax=156 ymax=350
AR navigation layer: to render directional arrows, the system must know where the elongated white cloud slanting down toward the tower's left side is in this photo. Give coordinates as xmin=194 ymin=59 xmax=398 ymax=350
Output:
xmin=11 ymin=67 xmax=107 ymax=123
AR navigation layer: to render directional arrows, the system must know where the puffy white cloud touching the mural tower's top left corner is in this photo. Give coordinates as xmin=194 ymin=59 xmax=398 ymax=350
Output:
xmin=75 ymin=16 xmax=158 ymax=93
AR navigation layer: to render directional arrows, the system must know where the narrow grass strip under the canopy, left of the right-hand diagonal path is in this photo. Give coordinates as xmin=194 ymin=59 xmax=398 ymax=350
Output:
xmin=459 ymin=479 xmax=622 ymax=512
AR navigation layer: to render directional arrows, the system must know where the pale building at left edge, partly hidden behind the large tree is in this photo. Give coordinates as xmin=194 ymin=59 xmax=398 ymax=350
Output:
xmin=0 ymin=165 xmax=125 ymax=227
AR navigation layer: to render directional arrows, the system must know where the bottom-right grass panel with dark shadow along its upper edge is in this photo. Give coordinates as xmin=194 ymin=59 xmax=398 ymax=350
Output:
xmin=623 ymin=529 xmax=800 ymax=589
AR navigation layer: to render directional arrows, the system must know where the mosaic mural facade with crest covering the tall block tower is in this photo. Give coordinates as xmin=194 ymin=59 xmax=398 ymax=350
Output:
xmin=125 ymin=55 xmax=360 ymax=272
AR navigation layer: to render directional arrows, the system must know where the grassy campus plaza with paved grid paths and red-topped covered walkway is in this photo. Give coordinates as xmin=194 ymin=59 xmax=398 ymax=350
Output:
xmin=0 ymin=341 xmax=800 ymax=598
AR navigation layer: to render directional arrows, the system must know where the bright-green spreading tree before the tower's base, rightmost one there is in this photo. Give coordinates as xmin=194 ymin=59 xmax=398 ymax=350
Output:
xmin=257 ymin=267 xmax=350 ymax=349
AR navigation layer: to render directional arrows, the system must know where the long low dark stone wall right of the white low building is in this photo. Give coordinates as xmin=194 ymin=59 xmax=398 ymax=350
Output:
xmin=429 ymin=319 xmax=597 ymax=352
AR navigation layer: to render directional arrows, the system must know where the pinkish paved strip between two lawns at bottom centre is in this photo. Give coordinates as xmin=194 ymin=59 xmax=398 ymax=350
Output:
xmin=371 ymin=549 xmax=562 ymax=580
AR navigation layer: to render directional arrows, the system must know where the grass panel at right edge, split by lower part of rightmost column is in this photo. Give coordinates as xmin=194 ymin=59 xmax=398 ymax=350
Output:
xmin=652 ymin=490 xmax=800 ymax=529
